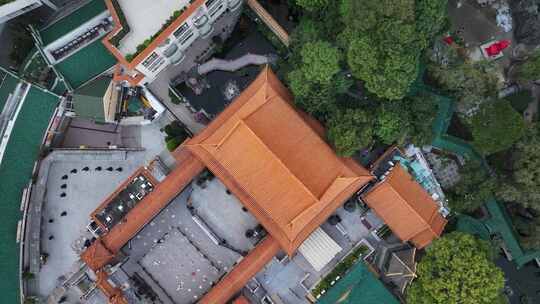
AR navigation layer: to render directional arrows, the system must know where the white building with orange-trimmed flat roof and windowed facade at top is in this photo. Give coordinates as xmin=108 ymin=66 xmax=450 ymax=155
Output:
xmin=108 ymin=0 xmax=243 ymax=83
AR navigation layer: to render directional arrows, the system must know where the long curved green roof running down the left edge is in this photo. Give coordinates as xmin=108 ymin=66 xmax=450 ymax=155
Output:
xmin=0 ymin=83 xmax=58 ymax=303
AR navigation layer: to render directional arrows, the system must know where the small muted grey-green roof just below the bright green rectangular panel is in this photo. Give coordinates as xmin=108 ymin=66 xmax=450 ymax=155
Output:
xmin=73 ymin=77 xmax=111 ymax=122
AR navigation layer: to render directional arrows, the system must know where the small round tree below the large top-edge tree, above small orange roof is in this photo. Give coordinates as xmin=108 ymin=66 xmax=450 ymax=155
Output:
xmin=375 ymin=101 xmax=410 ymax=144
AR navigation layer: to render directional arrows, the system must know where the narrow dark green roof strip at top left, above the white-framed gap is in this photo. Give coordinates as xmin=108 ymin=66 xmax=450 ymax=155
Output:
xmin=40 ymin=0 xmax=107 ymax=45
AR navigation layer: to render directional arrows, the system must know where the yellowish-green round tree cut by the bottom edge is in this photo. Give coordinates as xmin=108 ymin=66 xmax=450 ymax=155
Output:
xmin=407 ymin=232 xmax=504 ymax=304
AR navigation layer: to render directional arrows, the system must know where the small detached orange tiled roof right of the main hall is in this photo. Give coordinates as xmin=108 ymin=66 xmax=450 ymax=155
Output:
xmin=364 ymin=165 xmax=447 ymax=249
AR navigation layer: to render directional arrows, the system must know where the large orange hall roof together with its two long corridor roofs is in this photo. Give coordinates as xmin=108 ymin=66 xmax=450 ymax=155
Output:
xmin=82 ymin=68 xmax=373 ymax=303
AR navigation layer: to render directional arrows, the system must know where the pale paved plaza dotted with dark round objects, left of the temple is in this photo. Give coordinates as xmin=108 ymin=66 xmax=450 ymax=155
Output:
xmin=38 ymin=154 xmax=146 ymax=295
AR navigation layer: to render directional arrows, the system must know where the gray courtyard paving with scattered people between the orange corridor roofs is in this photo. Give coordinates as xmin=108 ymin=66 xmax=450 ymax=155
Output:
xmin=122 ymin=187 xmax=241 ymax=304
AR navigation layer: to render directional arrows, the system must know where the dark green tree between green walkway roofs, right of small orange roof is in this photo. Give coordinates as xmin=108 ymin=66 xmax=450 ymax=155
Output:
xmin=448 ymin=159 xmax=497 ymax=213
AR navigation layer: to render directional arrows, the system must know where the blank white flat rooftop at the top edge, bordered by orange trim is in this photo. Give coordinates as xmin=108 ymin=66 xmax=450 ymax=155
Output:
xmin=118 ymin=0 xmax=189 ymax=55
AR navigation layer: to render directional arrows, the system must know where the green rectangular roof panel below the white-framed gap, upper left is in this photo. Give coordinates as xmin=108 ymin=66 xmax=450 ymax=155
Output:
xmin=55 ymin=40 xmax=116 ymax=89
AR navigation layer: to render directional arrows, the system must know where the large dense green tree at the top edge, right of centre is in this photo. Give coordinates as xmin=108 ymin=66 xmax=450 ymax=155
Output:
xmin=338 ymin=0 xmax=447 ymax=99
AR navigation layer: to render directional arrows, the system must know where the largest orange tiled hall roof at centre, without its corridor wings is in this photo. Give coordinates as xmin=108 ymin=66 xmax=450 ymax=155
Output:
xmin=184 ymin=68 xmax=372 ymax=255
